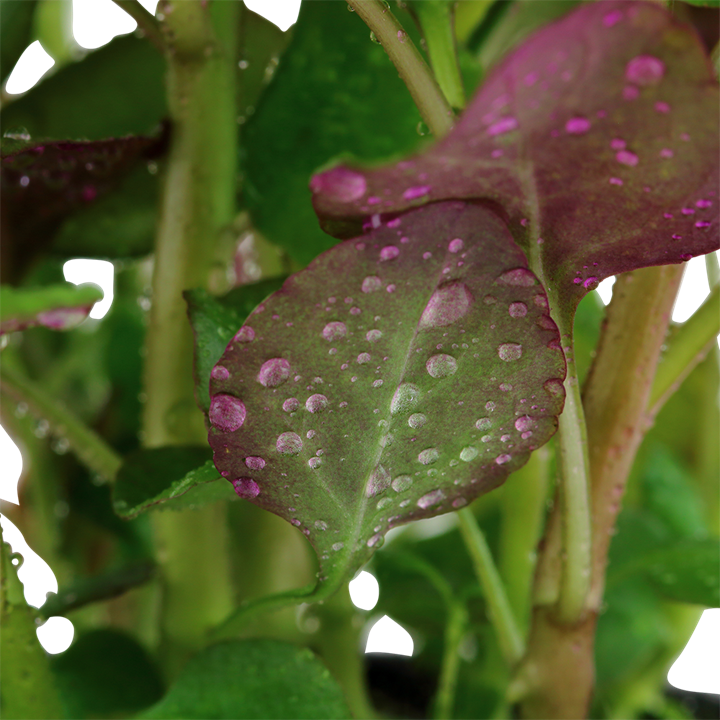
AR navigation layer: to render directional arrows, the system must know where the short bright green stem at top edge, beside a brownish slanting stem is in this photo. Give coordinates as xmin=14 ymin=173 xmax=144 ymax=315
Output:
xmin=416 ymin=0 xmax=465 ymax=110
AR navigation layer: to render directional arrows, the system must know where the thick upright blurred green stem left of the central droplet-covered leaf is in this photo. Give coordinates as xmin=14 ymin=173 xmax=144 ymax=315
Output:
xmin=143 ymin=0 xmax=239 ymax=674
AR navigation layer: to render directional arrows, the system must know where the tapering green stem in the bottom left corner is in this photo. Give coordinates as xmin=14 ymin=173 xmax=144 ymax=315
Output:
xmin=0 ymin=532 xmax=64 ymax=720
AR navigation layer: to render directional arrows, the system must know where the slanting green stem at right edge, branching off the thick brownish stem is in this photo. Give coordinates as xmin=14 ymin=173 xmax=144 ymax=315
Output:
xmin=648 ymin=278 xmax=720 ymax=417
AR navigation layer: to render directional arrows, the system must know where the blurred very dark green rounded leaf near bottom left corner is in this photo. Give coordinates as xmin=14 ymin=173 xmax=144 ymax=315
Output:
xmin=51 ymin=630 xmax=164 ymax=720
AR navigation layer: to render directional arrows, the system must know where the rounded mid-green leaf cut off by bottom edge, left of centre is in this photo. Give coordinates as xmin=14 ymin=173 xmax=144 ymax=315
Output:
xmin=137 ymin=640 xmax=351 ymax=720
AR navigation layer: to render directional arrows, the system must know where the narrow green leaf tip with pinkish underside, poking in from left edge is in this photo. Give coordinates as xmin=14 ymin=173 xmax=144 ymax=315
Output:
xmin=0 ymin=282 xmax=105 ymax=335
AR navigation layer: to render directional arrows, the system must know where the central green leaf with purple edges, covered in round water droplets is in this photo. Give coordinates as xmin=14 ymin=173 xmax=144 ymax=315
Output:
xmin=208 ymin=202 xmax=565 ymax=582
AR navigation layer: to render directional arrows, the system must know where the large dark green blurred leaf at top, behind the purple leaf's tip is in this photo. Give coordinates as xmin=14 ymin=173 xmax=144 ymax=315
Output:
xmin=242 ymin=0 xmax=421 ymax=265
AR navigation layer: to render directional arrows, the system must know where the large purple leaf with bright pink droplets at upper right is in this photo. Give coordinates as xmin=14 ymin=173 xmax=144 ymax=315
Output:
xmin=312 ymin=0 xmax=720 ymax=311
